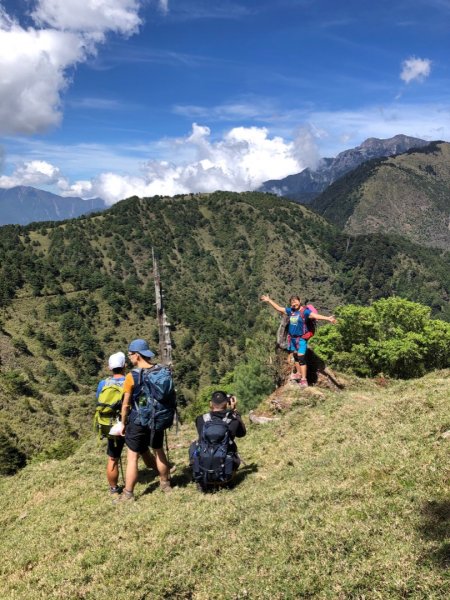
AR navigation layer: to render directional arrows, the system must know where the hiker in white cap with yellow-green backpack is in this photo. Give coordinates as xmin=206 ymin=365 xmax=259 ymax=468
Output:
xmin=95 ymin=352 xmax=156 ymax=499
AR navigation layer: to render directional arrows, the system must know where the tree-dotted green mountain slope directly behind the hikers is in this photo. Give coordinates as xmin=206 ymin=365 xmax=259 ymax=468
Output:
xmin=0 ymin=192 xmax=450 ymax=462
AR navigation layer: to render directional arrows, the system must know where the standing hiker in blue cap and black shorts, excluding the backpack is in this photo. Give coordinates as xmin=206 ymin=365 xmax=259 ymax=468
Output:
xmin=117 ymin=339 xmax=175 ymax=500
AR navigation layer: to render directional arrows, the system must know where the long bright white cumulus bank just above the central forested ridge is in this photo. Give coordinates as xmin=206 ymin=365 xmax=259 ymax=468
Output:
xmin=54 ymin=123 xmax=304 ymax=204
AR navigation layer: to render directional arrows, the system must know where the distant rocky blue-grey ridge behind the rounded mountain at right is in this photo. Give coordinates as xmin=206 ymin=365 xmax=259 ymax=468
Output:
xmin=258 ymin=135 xmax=429 ymax=204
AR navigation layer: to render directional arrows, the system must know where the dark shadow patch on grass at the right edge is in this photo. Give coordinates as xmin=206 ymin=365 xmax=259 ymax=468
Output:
xmin=419 ymin=499 xmax=450 ymax=568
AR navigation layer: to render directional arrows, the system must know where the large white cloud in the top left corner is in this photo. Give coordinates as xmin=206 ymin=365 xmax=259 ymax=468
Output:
xmin=0 ymin=0 xmax=140 ymax=134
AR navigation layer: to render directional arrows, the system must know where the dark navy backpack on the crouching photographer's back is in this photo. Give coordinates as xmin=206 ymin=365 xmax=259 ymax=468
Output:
xmin=191 ymin=413 xmax=236 ymax=489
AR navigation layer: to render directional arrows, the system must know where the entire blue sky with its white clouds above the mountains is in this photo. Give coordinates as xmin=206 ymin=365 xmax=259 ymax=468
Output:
xmin=0 ymin=0 xmax=450 ymax=203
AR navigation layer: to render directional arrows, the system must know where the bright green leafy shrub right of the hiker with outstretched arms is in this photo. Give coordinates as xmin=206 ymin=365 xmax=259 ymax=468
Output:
xmin=314 ymin=297 xmax=450 ymax=379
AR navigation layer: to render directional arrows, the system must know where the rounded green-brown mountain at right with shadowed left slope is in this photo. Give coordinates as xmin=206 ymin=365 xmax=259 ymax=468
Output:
xmin=311 ymin=142 xmax=450 ymax=250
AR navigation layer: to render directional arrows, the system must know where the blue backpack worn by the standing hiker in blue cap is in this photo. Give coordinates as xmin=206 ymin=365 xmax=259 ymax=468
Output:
xmin=131 ymin=365 xmax=177 ymax=431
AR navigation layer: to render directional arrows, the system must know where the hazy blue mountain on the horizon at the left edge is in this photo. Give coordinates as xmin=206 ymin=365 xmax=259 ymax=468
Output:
xmin=0 ymin=185 xmax=106 ymax=225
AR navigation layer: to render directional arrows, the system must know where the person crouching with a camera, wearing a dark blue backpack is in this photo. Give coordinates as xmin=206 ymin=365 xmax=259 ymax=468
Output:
xmin=189 ymin=391 xmax=247 ymax=491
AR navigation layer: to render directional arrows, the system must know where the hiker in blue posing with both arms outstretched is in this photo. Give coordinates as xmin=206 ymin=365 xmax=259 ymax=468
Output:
xmin=261 ymin=295 xmax=336 ymax=387
